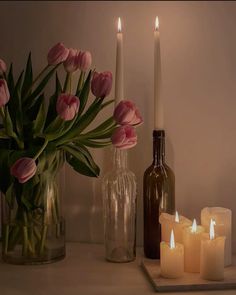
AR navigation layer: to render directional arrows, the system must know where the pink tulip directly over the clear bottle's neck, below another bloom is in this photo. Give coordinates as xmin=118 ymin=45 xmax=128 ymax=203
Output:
xmin=111 ymin=125 xmax=137 ymax=149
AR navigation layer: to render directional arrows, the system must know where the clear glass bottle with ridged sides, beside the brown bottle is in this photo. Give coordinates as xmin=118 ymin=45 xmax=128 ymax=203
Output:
xmin=102 ymin=149 xmax=136 ymax=262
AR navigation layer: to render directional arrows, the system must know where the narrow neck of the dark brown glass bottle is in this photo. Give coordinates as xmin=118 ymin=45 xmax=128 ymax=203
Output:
xmin=153 ymin=130 xmax=165 ymax=166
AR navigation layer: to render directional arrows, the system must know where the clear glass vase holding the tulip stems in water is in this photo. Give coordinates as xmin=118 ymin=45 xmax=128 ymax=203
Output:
xmin=2 ymin=151 xmax=65 ymax=264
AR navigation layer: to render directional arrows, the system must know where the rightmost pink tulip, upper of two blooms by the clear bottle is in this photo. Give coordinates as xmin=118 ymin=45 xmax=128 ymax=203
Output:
xmin=114 ymin=100 xmax=143 ymax=125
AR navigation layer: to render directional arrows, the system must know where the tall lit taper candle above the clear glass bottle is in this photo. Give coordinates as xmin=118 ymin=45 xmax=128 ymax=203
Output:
xmin=115 ymin=17 xmax=124 ymax=105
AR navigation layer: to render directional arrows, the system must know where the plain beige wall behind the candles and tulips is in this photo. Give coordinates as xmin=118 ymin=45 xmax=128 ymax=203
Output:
xmin=0 ymin=1 xmax=236 ymax=250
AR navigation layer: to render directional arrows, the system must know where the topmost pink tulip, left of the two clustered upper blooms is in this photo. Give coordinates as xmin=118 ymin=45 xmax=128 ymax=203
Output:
xmin=48 ymin=43 xmax=69 ymax=66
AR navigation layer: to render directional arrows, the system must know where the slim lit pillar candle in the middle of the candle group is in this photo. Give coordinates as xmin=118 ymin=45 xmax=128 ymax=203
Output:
xmin=183 ymin=219 xmax=205 ymax=272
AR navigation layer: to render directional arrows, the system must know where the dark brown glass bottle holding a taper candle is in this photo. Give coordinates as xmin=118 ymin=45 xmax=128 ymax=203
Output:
xmin=143 ymin=130 xmax=175 ymax=259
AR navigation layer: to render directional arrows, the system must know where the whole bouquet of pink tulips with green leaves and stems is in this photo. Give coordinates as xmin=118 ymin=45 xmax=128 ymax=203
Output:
xmin=0 ymin=43 xmax=142 ymax=264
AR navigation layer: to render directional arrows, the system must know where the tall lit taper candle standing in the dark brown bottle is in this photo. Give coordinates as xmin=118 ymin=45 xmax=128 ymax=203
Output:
xmin=154 ymin=17 xmax=164 ymax=130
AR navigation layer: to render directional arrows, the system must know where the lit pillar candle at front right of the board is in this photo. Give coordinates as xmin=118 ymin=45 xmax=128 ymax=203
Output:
xmin=200 ymin=219 xmax=225 ymax=281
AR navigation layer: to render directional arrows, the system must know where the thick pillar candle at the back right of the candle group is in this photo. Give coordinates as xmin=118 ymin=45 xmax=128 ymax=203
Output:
xmin=201 ymin=207 xmax=232 ymax=266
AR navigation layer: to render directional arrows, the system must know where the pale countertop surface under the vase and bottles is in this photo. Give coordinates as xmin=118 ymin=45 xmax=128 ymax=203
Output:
xmin=0 ymin=243 xmax=236 ymax=295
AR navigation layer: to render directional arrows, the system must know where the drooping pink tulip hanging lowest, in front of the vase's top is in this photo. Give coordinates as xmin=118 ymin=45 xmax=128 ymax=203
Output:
xmin=10 ymin=157 xmax=37 ymax=183
